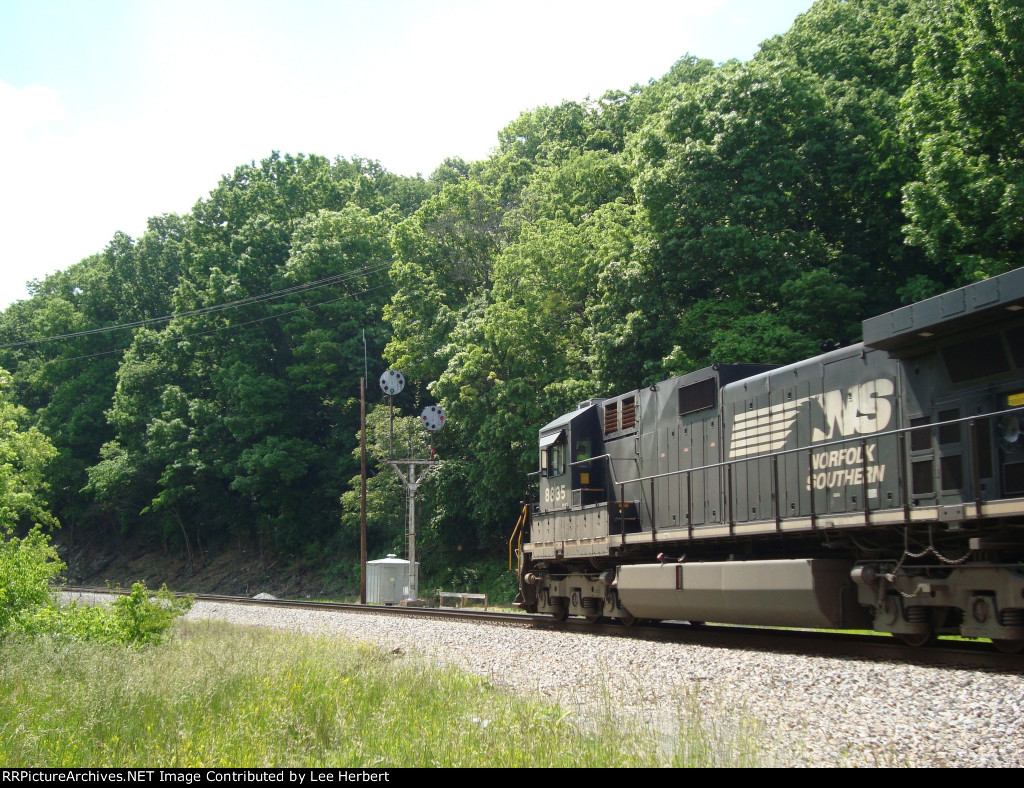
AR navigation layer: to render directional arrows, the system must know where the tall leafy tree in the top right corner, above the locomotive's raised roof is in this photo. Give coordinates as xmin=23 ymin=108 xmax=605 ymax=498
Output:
xmin=901 ymin=0 xmax=1024 ymax=287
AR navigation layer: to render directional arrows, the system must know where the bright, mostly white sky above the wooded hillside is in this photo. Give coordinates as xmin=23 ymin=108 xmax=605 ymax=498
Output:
xmin=0 ymin=0 xmax=812 ymax=310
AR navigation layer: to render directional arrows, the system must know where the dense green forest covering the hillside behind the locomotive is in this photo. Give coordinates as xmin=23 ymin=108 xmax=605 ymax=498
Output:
xmin=0 ymin=0 xmax=1024 ymax=589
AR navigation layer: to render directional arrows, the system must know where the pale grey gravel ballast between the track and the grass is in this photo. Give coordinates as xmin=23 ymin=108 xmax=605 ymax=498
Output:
xmin=59 ymin=595 xmax=1024 ymax=768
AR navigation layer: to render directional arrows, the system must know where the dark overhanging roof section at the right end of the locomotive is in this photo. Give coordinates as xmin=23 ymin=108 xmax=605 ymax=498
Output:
xmin=863 ymin=268 xmax=1024 ymax=351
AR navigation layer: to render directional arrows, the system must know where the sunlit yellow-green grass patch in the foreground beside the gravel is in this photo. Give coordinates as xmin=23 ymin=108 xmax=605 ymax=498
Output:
xmin=0 ymin=621 xmax=757 ymax=768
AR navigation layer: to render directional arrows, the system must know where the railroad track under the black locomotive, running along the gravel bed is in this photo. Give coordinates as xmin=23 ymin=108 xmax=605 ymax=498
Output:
xmin=60 ymin=586 xmax=1024 ymax=673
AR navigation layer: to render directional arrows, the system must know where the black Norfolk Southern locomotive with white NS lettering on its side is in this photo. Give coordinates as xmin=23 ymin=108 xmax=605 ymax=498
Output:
xmin=511 ymin=268 xmax=1024 ymax=651
